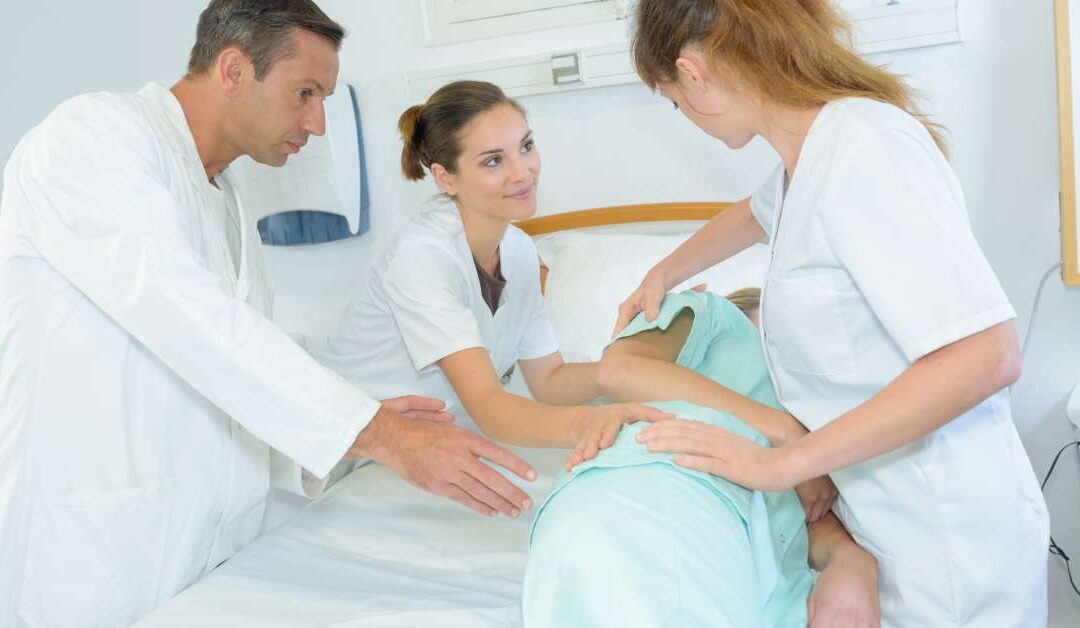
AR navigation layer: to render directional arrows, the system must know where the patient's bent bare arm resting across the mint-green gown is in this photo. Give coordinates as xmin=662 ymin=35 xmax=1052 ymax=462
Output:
xmin=596 ymin=308 xmax=806 ymax=446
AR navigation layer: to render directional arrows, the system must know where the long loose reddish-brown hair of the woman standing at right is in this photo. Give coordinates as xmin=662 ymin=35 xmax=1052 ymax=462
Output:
xmin=633 ymin=0 xmax=947 ymax=153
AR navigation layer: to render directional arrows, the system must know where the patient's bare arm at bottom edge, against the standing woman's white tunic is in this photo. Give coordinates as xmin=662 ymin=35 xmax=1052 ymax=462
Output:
xmin=807 ymin=512 xmax=881 ymax=628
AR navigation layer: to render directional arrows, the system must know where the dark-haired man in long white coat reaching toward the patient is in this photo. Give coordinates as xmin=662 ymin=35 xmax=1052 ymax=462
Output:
xmin=0 ymin=0 xmax=535 ymax=628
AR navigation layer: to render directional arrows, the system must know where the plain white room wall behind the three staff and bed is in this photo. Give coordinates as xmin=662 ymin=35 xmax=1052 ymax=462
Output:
xmin=0 ymin=0 xmax=1080 ymax=626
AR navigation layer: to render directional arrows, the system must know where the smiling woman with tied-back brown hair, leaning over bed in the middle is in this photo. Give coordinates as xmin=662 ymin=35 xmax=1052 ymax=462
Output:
xmin=316 ymin=81 xmax=670 ymax=499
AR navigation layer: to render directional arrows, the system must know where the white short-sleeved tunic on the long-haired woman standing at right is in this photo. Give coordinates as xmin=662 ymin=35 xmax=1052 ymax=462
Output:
xmin=752 ymin=98 xmax=1049 ymax=628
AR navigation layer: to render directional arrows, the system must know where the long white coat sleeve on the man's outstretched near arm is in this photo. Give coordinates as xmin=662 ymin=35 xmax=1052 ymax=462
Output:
xmin=4 ymin=96 xmax=379 ymax=476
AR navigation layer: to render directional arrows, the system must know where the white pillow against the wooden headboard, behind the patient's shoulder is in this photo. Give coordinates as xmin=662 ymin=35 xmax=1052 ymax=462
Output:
xmin=537 ymin=232 xmax=767 ymax=362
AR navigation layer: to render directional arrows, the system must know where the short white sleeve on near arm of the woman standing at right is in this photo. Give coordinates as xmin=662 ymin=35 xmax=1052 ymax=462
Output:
xmin=822 ymin=124 xmax=1016 ymax=362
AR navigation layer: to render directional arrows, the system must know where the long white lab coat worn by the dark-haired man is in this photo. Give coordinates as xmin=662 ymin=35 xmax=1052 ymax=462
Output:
xmin=0 ymin=84 xmax=378 ymax=628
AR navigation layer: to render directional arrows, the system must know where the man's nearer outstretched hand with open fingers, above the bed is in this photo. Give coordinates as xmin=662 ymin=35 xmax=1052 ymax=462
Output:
xmin=348 ymin=404 xmax=537 ymax=517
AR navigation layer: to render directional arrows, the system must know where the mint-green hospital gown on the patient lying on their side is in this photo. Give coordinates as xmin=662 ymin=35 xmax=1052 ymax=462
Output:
xmin=523 ymin=292 xmax=813 ymax=628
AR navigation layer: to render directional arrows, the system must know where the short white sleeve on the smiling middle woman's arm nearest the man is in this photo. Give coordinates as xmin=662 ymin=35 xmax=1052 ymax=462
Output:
xmin=384 ymin=237 xmax=484 ymax=372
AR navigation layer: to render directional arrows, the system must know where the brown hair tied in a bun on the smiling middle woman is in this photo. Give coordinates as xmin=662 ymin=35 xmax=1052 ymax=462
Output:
xmin=397 ymin=81 xmax=525 ymax=181
